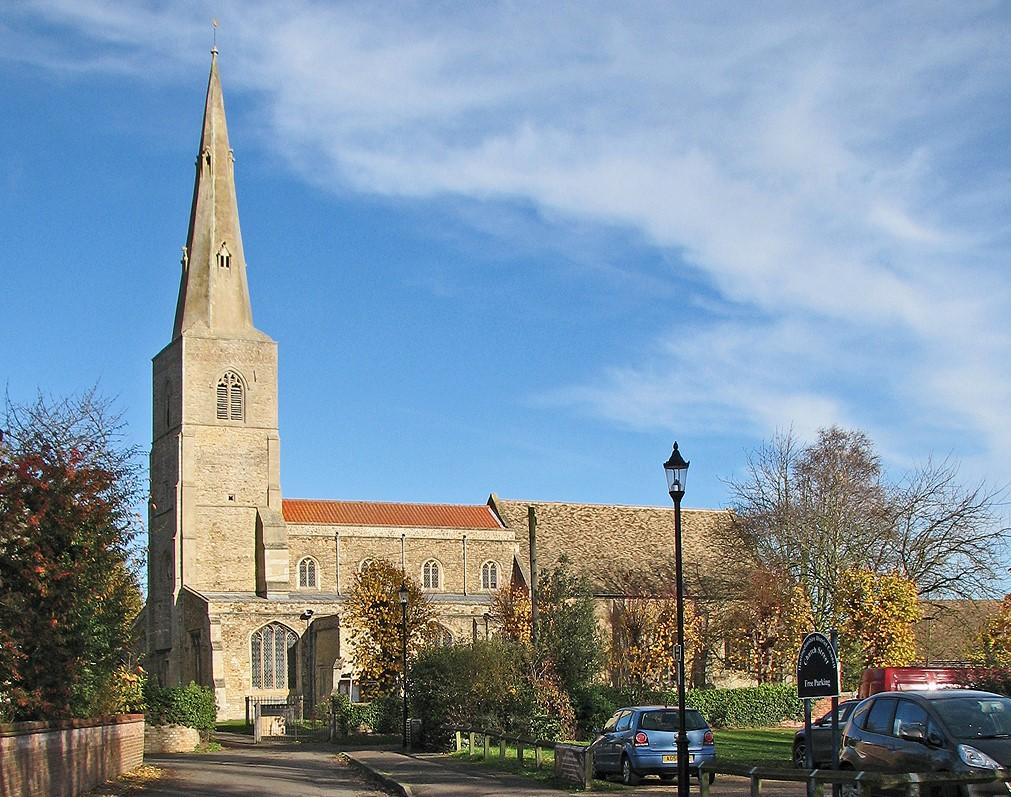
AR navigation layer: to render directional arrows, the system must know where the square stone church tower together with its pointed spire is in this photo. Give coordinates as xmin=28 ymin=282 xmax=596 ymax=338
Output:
xmin=148 ymin=51 xmax=289 ymax=683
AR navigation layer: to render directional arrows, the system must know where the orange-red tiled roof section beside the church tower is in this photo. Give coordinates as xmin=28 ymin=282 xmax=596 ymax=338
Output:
xmin=281 ymin=499 xmax=502 ymax=529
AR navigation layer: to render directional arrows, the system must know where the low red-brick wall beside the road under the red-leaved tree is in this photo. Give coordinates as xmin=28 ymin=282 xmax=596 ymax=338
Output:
xmin=0 ymin=714 xmax=144 ymax=797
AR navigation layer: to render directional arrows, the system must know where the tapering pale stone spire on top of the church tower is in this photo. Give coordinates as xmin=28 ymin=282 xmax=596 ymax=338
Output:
xmin=172 ymin=48 xmax=261 ymax=340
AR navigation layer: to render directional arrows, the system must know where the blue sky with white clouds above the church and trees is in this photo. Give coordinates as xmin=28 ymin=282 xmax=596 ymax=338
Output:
xmin=0 ymin=0 xmax=1011 ymax=521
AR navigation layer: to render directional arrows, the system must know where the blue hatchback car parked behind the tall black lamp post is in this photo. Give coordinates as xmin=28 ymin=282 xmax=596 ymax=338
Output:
xmin=589 ymin=706 xmax=716 ymax=786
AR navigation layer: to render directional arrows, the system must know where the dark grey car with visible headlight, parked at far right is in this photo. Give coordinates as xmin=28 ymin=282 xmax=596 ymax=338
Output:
xmin=841 ymin=689 xmax=1011 ymax=795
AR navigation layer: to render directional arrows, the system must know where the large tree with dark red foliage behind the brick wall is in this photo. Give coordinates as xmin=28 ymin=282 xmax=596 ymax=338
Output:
xmin=0 ymin=390 xmax=141 ymax=720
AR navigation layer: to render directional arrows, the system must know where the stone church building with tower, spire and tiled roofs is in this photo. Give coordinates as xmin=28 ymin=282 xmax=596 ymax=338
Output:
xmin=146 ymin=51 xmax=726 ymax=718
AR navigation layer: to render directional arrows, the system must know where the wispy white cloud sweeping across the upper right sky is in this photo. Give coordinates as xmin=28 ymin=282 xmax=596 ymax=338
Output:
xmin=2 ymin=0 xmax=1011 ymax=479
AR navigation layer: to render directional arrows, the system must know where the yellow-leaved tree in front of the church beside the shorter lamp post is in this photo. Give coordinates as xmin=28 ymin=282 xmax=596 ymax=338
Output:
xmin=343 ymin=559 xmax=436 ymax=697
